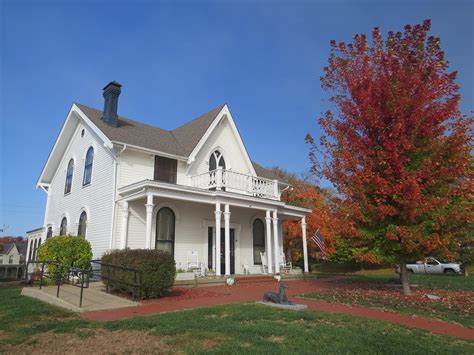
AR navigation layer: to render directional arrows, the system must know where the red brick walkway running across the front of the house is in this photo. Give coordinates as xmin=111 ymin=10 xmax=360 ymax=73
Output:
xmin=81 ymin=280 xmax=474 ymax=339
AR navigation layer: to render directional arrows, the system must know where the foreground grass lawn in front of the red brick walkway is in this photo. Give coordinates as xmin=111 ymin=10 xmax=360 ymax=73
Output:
xmin=0 ymin=288 xmax=474 ymax=354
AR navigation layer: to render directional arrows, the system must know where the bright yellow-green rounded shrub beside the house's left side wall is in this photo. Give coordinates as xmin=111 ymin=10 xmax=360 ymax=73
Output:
xmin=38 ymin=235 xmax=92 ymax=277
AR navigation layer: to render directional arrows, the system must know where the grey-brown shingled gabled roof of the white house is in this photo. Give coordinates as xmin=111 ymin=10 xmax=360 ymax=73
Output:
xmin=76 ymin=103 xmax=278 ymax=180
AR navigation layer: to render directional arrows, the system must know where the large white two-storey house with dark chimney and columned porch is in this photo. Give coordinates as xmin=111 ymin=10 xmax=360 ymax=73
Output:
xmin=28 ymin=82 xmax=311 ymax=275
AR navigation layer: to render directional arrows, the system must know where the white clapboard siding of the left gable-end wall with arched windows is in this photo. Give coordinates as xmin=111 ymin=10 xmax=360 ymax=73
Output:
xmin=45 ymin=125 xmax=114 ymax=258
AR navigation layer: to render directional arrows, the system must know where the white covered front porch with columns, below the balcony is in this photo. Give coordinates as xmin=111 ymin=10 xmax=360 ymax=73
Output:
xmin=115 ymin=180 xmax=311 ymax=276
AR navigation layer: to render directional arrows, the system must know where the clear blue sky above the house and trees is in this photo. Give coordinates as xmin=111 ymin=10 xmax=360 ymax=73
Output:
xmin=0 ymin=0 xmax=474 ymax=239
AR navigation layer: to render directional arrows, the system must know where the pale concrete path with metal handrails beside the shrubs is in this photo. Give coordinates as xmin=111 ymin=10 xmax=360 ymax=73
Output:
xmin=21 ymin=282 xmax=139 ymax=312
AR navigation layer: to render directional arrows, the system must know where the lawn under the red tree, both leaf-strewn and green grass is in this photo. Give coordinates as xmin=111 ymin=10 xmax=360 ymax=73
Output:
xmin=303 ymin=269 xmax=474 ymax=328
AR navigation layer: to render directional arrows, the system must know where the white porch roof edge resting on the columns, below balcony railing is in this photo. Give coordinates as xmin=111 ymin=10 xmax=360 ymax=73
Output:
xmin=118 ymin=180 xmax=312 ymax=218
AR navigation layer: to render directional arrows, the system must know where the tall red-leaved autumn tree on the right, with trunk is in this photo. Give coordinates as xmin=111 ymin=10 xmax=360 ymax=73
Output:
xmin=307 ymin=20 xmax=473 ymax=294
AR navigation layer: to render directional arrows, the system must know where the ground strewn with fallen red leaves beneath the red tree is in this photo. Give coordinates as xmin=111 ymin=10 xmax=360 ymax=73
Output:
xmin=303 ymin=276 xmax=474 ymax=328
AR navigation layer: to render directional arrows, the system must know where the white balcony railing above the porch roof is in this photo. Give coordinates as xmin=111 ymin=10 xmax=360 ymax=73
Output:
xmin=191 ymin=168 xmax=280 ymax=200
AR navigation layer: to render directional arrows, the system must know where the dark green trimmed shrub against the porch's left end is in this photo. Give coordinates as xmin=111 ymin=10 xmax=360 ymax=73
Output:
xmin=102 ymin=249 xmax=176 ymax=299
